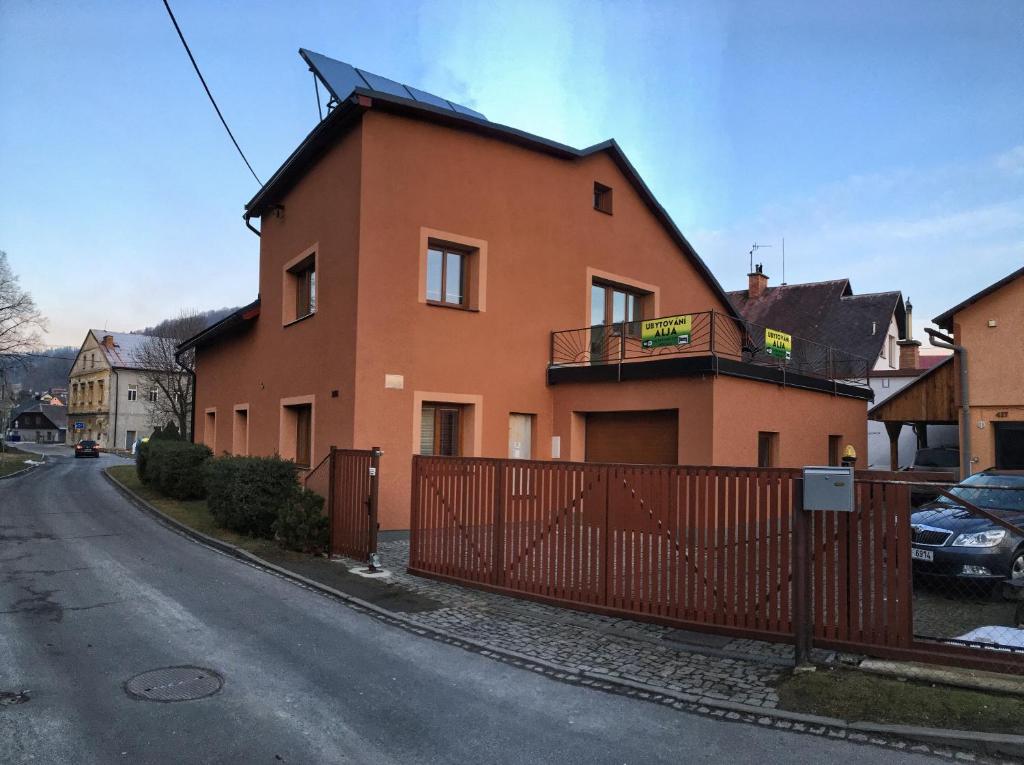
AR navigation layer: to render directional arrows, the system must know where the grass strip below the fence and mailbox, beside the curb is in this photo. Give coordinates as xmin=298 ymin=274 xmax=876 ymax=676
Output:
xmin=777 ymin=669 xmax=1024 ymax=734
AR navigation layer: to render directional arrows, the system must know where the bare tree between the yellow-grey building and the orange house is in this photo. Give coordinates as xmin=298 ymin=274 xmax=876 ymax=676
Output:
xmin=134 ymin=311 xmax=206 ymax=438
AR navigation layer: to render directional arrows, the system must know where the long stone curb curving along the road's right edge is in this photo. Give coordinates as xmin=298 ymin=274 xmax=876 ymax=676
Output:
xmin=102 ymin=469 xmax=1024 ymax=762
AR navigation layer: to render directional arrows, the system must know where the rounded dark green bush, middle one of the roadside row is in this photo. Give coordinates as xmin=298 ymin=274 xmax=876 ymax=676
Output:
xmin=206 ymin=457 xmax=299 ymax=539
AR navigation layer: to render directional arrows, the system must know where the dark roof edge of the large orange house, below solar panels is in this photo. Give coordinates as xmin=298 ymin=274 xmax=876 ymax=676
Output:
xmin=245 ymin=49 xmax=739 ymax=318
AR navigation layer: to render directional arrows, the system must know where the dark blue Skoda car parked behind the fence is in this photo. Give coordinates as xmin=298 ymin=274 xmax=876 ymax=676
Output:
xmin=910 ymin=469 xmax=1024 ymax=584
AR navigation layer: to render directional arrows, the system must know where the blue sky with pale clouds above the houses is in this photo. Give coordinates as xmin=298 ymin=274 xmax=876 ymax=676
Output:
xmin=0 ymin=0 xmax=1024 ymax=344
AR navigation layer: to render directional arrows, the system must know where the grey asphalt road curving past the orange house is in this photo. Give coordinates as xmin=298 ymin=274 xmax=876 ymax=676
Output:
xmin=0 ymin=448 xmax=937 ymax=765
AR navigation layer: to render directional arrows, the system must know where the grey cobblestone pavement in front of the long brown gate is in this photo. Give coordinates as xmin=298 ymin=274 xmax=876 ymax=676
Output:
xmin=334 ymin=535 xmax=793 ymax=708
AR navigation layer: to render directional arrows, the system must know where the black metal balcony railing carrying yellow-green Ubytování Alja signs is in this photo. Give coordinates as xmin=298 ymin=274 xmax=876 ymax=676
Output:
xmin=550 ymin=311 xmax=871 ymax=386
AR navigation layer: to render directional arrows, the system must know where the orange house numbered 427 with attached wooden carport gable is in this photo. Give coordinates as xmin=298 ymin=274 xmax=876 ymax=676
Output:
xmin=869 ymin=268 xmax=1024 ymax=475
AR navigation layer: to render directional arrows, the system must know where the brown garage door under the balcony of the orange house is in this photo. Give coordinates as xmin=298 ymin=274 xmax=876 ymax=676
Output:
xmin=586 ymin=409 xmax=679 ymax=465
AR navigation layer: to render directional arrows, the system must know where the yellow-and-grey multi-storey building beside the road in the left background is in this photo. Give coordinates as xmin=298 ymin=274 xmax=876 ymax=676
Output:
xmin=68 ymin=330 xmax=181 ymax=450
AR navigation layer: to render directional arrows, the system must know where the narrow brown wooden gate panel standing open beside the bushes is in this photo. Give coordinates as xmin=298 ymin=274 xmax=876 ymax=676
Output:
xmin=304 ymin=448 xmax=381 ymax=560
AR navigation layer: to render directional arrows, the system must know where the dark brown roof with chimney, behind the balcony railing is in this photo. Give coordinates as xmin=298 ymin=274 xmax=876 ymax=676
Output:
xmin=729 ymin=279 xmax=906 ymax=359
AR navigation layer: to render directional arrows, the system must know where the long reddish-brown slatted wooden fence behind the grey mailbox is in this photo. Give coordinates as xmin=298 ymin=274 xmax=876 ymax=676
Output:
xmin=410 ymin=457 xmax=1024 ymax=672
